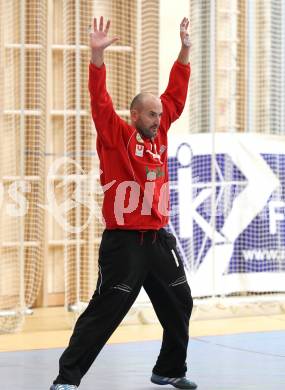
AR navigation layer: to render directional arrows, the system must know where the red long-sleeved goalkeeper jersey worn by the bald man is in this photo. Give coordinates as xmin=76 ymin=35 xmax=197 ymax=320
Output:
xmin=89 ymin=61 xmax=190 ymax=230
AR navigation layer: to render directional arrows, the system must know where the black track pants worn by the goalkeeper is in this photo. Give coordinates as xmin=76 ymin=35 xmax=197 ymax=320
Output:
xmin=54 ymin=229 xmax=193 ymax=386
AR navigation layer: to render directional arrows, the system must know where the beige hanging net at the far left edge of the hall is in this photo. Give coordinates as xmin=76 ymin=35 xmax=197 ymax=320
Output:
xmin=0 ymin=0 xmax=46 ymax=332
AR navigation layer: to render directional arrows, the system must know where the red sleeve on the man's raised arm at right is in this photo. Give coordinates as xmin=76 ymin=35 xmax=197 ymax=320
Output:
xmin=160 ymin=61 xmax=191 ymax=130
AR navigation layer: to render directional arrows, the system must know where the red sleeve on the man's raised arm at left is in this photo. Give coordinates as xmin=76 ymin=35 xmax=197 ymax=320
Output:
xmin=88 ymin=63 xmax=124 ymax=147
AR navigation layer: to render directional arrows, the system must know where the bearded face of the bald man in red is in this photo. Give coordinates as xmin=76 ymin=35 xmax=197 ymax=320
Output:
xmin=131 ymin=96 xmax=162 ymax=138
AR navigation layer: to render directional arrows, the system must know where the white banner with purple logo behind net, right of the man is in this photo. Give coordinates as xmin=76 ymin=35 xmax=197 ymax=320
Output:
xmin=168 ymin=133 xmax=285 ymax=297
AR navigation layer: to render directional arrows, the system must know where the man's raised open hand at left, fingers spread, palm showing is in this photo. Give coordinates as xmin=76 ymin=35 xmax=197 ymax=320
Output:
xmin=89 ymin=16 xmax=119 ymax=50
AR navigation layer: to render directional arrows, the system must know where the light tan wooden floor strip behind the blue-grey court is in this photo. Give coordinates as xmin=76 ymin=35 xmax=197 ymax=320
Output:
xmin=0 ymin=307 xmax=285 ymax=352
